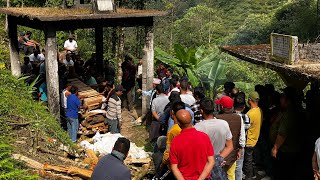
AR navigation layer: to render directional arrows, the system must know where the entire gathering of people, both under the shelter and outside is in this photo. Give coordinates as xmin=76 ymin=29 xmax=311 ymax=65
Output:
xmin=18 ymin=32 xmax=320 ymax=180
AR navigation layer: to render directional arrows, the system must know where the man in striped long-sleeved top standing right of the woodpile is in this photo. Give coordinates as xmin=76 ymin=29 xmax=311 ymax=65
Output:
xmin=105 ymin=85 xmax=126 ymax=134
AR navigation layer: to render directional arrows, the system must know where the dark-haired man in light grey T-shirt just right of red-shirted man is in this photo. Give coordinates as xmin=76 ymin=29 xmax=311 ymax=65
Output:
xmin=194 ymin=98 xmax=233 ymax=179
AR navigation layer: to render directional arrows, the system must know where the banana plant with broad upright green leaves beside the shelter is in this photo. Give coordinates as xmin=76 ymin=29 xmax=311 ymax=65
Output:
xmin=155 ymin=44 xmax=218 ymax=87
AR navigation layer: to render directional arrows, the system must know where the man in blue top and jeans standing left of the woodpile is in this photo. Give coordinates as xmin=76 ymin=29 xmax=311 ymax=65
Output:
xmin=66 ymin=86 xmax=84 ymax=142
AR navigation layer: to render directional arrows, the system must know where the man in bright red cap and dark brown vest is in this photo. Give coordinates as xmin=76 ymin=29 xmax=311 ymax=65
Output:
xmin=216 ymin=96 xmax=246 ymax=180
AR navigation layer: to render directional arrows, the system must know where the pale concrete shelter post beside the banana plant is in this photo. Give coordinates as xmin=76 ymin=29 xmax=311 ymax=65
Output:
xmin=142 ymin=26 xmax=154 ymax=115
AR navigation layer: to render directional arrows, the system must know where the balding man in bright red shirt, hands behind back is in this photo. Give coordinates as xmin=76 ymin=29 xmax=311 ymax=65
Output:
xmin=169 ymin=109 xmax=214 ymax=180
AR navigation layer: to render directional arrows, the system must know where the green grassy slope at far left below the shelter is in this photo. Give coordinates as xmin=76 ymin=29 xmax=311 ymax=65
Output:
xmin=0 ymin=70 xmax=72 ymax=179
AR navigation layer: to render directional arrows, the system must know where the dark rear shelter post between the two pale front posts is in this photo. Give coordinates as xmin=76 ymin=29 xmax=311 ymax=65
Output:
xmin=94 ymin=26 xmax=104 ymax=75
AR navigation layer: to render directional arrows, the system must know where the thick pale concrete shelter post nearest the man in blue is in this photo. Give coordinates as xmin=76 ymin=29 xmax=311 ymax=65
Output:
xmin=45 ymin=25 xmax=60 ymax=119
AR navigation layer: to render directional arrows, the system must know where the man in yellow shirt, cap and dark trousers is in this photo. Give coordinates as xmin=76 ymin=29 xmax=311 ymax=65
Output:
xmin=243 ymin=91 xmax=262 ymax=180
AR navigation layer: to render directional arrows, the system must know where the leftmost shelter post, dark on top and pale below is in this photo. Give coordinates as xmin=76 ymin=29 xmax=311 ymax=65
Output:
xmin=7 ymin=16 xmax=21 ymax=77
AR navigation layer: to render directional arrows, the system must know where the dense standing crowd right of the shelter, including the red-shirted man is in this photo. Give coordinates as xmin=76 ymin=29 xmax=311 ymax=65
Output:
xmin=142 ymin=66 xmax=320 ymax=180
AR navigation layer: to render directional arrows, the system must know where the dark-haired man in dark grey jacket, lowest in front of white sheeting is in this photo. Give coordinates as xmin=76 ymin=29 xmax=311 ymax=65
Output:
xmin=91 ymin=137 xmax=131 ymax=180
